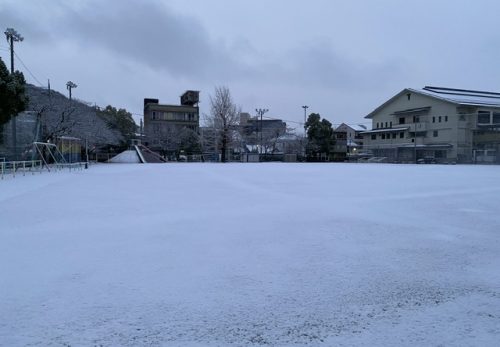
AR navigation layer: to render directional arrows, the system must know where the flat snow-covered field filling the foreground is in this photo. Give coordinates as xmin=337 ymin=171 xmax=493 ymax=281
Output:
xmin=0 ymin=164 xmax=500 ymax=346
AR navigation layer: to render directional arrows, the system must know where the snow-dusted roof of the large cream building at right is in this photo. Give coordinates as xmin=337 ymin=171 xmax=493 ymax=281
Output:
xmin=365 ymin=86 xmax=500 ymax=118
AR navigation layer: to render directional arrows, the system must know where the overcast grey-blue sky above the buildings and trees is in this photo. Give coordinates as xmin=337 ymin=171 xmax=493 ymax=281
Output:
xmin=0 ymin=0 xmax=500 ymax=128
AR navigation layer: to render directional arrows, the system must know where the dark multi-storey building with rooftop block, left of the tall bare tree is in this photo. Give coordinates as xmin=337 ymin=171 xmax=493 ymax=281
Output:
xmin=144 ymin=90 xmax=200 ymax=153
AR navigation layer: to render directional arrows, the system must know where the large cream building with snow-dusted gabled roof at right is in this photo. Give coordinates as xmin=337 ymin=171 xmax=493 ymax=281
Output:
xmin=361 ymin=87 xmax=500 ymax=163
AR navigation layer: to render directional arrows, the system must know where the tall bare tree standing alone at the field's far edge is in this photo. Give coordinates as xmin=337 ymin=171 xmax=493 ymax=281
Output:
xmin=208 ymin=86 xmax=240 ymax=162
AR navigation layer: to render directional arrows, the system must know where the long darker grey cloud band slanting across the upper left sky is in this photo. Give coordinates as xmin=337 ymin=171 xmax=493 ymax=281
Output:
xmin=0 ymin=0 xmax=398 ymax=92
